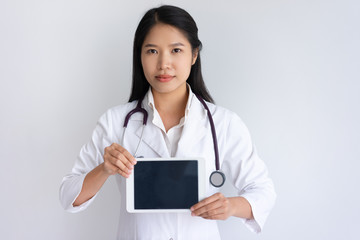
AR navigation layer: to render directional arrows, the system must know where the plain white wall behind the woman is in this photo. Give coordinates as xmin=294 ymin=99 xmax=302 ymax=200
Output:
xmin=0 ymin=0 xmax=360 ymax=240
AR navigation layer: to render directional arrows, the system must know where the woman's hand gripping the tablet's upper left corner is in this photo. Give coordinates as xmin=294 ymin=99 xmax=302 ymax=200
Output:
xmin=103 ymin=143 xmax=136 ymax=178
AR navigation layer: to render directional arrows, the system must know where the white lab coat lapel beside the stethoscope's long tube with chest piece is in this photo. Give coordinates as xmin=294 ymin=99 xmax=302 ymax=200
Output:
xmin=175 ymin=96 xmax=208 ymax=157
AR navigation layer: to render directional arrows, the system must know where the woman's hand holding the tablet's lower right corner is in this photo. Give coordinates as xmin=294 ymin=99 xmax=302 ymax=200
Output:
xmin=190 ymin=193 xmax=234 ymax=220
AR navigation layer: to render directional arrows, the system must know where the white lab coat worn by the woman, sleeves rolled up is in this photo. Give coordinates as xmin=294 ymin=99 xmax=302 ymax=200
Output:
xmin=60 ymin=89 xmax=276 ymax=240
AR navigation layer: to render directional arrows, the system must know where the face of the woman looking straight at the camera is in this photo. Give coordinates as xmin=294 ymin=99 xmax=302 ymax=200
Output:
xmin=141 ymin=23 xmax=197 ymax=96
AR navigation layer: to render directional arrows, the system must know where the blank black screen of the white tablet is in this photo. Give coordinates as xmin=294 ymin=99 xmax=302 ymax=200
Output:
xmin=133 ymin=160 xmax=199 ymax=210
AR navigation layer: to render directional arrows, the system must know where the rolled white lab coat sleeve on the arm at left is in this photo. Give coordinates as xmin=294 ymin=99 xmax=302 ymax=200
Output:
xmin=59 ymin=110 xmax=112 ymax=213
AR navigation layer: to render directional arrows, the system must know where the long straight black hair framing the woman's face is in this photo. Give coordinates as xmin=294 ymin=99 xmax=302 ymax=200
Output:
xmin=129 ymin=5 xmax=214 ymax=103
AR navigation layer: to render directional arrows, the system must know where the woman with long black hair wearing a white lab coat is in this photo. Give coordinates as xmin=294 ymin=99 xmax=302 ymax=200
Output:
xmin=60 ymin=6 xmax=275 ymax=239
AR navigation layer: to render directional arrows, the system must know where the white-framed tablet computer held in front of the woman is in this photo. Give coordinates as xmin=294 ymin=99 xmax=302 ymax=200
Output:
xmin=126 ymin=158 xmax=206 ymax=213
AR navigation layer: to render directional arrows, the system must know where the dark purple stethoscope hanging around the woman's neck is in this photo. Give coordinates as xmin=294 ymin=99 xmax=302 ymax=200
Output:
xmin=122 ymin=94 xmax=226 ymax=187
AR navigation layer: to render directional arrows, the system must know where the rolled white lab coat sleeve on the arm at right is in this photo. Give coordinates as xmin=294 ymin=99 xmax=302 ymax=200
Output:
xmin=223 ymin=114 xmax=276 ymax=233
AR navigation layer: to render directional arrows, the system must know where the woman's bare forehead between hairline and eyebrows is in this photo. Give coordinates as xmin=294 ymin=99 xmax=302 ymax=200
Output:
xmin=143 ymin=23 xmax=190 ymax=46
